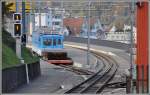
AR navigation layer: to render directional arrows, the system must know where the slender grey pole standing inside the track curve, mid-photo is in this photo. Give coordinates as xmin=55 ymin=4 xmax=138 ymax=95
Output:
xmin=87 ymin=1 xmax=91 ymax=65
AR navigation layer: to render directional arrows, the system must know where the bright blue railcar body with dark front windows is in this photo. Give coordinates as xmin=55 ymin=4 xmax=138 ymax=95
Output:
xmin=32 ymin=32 xmax=64 ymax=56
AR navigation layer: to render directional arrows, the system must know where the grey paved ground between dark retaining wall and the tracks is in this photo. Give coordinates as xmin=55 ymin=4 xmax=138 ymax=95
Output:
xmin=13 ymin=60 xmax=84 ymax=94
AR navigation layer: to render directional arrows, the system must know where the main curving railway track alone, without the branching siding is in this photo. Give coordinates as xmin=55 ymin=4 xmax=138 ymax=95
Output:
xmin=65 ymin=51 xmax=118 ymax=94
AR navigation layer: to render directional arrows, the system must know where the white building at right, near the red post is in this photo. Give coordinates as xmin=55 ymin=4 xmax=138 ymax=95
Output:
xmin=106 ymin=25 xmax=136 ymax=43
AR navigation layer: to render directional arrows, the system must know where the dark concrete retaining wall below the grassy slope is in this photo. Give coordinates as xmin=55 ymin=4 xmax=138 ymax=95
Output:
xmin=2 ymin=62 xmax=41 ymax=93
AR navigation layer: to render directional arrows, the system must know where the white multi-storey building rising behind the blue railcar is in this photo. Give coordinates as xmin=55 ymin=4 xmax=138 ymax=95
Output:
xmin=33 ymin=8 xmax=65 ymax=34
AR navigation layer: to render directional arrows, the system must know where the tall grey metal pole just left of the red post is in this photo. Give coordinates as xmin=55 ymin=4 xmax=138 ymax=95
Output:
xmin=130 ymin=0 xmax=135 ymax=93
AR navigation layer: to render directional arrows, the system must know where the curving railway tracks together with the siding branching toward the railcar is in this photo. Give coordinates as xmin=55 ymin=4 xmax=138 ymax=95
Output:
xmin=43 ymin=45 xmax=118 ymax=94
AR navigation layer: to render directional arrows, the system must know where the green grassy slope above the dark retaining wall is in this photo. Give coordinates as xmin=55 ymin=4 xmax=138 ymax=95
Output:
xmin=2 ymin=30 xmax=39 ymax=69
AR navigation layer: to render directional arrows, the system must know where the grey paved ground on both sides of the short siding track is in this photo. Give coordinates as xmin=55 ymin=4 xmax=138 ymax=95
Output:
xmin=13 ymin=48 xmax=101 ymax=93
